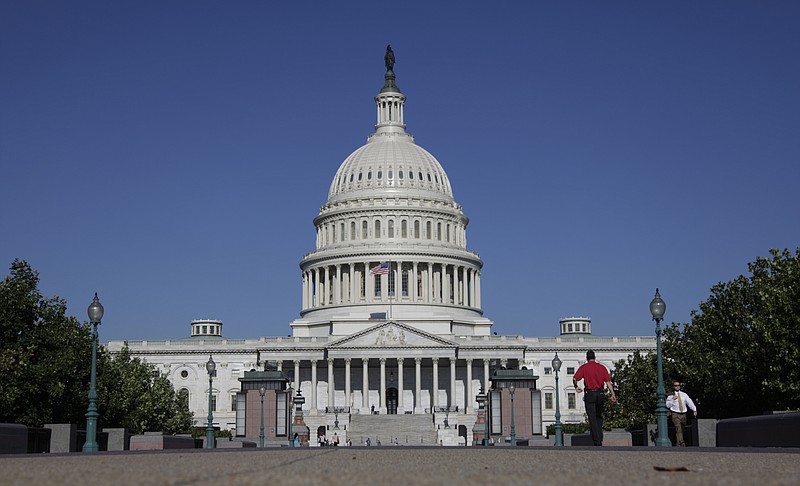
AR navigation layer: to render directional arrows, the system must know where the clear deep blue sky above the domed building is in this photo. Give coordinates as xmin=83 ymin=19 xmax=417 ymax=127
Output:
xmin=0 ymin=0 xmax=800 ymax=341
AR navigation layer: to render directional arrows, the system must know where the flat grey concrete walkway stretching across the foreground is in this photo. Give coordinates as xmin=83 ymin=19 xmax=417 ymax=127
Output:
xmin=0 ymin=446 xmax=800 ymax=486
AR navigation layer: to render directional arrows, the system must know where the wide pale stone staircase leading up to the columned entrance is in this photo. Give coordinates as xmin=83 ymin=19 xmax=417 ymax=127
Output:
xmin=347 ymin=414 xmax=438 ymax=446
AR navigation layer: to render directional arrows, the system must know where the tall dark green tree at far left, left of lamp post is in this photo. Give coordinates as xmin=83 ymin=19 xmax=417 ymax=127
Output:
xmin=0 ymin=260 xmax=91 ymax=426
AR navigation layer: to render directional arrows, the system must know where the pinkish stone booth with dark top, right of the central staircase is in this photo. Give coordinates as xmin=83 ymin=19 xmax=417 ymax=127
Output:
xmin=487 ymin=369 xmax=542 ymax=446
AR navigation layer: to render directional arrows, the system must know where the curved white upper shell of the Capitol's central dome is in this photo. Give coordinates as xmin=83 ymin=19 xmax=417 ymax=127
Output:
xmin=328 ymin=133 xmax=453 ymax=204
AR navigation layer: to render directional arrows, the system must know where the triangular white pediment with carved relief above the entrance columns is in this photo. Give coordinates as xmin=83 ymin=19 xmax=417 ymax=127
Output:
xmin=327 ymin=321 xmax=456 ymax=349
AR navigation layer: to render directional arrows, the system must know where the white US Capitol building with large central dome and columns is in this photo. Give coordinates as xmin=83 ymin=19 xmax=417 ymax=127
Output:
xmin=108 ymin=47 xmax=655 ymax=445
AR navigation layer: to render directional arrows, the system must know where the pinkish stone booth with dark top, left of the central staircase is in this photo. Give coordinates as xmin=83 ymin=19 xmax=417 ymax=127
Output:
xmin=236 ymin=370 xmax=292 ymax=442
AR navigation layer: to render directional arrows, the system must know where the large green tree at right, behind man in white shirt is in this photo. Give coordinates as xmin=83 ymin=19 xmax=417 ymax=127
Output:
xmin=664 ymin=248 xmax=800 ymax=418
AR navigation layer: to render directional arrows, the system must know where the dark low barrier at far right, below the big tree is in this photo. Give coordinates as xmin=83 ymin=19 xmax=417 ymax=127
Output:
xmin=717 ymin=412 xmax=800 ymax=447
